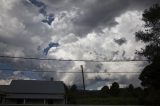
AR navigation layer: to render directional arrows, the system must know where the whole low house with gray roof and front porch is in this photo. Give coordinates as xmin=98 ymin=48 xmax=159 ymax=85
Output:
xmin=0 ymin=80 xmax=65 ymax=104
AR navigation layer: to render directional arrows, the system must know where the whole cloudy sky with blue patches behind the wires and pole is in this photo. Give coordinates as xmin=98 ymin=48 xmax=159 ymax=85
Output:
xmin=0 ymin=0 xmax=160 ymax=89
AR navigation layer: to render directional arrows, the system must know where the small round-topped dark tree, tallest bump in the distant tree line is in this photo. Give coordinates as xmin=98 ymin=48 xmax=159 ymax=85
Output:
xmin=110 ymin=82 xmax=119 ymax=96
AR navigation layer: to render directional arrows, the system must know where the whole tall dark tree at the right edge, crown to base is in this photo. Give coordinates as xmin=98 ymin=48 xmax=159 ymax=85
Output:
xmin=136 ymin=4 xmax=160 ymax=88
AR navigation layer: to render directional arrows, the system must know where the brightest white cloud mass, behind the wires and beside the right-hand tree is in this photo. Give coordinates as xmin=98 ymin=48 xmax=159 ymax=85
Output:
xmin=45 ymin=11 xmax=148 ymax=88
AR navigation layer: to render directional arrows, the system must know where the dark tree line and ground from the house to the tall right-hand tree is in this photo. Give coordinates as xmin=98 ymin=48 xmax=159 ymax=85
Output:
xmin=65 ymin=82 xmax=155 ymax=105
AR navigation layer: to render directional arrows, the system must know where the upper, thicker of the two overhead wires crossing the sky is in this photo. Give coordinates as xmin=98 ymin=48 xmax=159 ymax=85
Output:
xmin=0 ymin=56 xmax=148 ymax=62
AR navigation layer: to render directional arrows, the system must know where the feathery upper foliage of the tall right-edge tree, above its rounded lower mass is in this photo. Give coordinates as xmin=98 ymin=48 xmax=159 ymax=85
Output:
xmin=136 ymin=4 xmax=160 ymax=61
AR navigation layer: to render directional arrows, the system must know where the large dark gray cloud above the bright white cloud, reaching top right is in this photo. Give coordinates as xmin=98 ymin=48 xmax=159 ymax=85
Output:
xmin=70 ymin=0 xmax=159 ymax=36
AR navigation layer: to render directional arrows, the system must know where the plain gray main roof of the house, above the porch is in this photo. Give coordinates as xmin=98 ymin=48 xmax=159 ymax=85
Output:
xmin=7 ymin=80 xmax=65 ymax=94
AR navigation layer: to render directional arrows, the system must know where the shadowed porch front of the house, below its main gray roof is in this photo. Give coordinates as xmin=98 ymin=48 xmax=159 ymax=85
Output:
xmin=3 ymin=93 xmax=65 ymax=104
